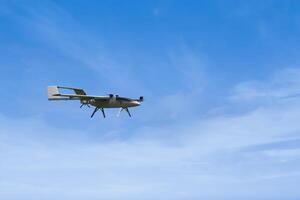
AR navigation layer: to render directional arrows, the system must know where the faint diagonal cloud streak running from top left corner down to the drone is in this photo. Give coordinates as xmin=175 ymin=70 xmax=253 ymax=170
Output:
xmin=2 ymin=1 xmax=142 ymax=94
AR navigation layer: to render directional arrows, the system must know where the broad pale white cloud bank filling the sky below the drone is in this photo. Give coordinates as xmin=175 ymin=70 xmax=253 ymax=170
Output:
xmin=0 ymin=69 xmax=300 ymax=199
